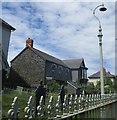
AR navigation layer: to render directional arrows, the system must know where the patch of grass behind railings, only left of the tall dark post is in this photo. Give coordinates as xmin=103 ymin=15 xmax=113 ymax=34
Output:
xmin=2 ymin=89 xmax=34 ymax=118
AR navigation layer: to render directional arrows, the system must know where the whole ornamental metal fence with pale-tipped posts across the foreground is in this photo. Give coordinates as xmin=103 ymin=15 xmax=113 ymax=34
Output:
xmin=8 ymin=93 xmax=117 ymax=120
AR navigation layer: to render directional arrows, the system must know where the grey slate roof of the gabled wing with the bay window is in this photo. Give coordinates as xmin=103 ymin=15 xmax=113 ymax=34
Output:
xmin=63 ymin=58 xmax=87 ymax=69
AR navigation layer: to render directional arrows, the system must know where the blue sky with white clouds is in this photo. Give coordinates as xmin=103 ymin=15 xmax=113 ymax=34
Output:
xmin=0 ymin=1 xmax=115 ymax=75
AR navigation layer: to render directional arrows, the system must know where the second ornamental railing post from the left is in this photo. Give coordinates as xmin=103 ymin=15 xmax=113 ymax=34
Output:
xmin=24 ymin=96 xmax=34 ymax=119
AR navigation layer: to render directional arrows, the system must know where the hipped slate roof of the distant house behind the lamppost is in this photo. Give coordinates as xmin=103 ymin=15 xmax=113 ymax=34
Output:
xmin=89 ymin=69 xmax=115 ymax=79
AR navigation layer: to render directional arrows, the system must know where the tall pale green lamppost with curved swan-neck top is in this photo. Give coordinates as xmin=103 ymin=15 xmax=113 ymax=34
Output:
xmin=93 ymin=4 xmax=107 ymax=96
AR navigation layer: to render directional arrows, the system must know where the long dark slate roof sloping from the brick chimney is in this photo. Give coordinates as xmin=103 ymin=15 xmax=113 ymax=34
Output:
xmin=11 ymin=46 xmax=68 ymax=67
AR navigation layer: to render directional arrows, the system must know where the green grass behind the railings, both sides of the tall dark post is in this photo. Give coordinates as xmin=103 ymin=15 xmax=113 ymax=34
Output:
xmin=2 ymin=90 xmax=58 ymax=118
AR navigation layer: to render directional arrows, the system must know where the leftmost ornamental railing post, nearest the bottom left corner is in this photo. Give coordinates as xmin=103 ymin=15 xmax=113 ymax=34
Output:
xmin=8 ymin=97 xmax=19 ymax=120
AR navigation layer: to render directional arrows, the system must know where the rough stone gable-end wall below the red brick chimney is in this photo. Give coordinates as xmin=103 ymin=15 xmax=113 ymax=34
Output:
xmin=9 ymin=48 xmax=45 ymax=87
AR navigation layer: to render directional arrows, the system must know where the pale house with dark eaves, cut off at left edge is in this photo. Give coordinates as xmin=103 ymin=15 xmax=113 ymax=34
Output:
xmin=0 ymin=18 xmax=15 ymax=70
